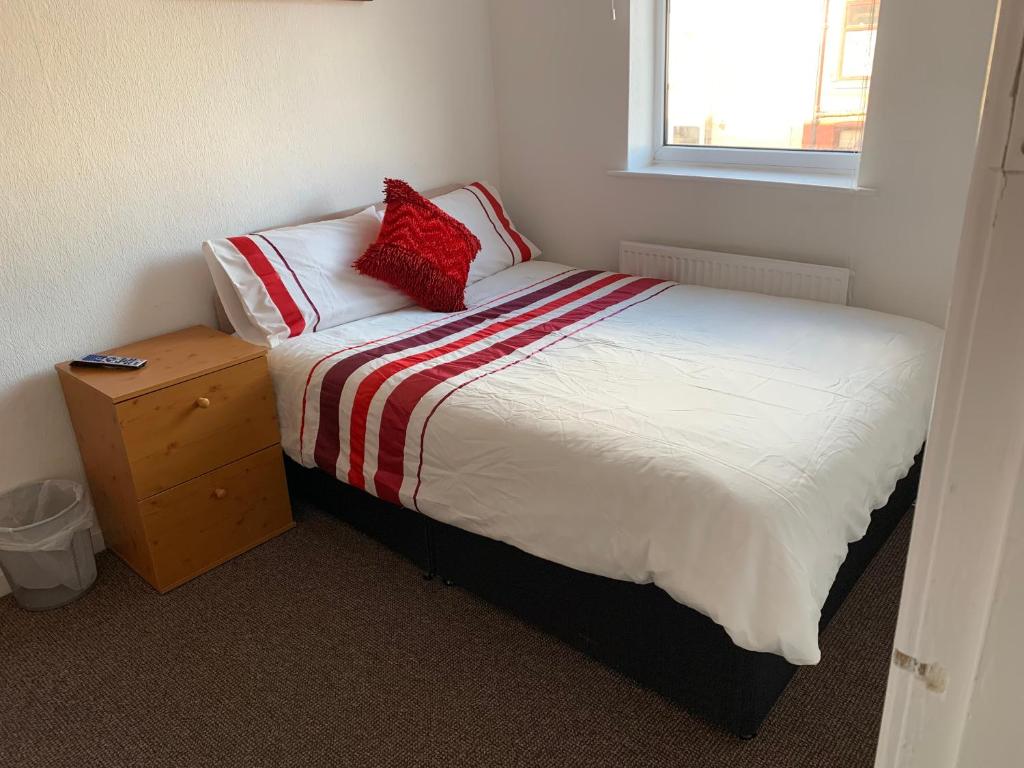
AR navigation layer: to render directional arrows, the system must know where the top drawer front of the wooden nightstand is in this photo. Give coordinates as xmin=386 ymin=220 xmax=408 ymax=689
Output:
xmin=117 ymin=357 xmax=281 ymax=499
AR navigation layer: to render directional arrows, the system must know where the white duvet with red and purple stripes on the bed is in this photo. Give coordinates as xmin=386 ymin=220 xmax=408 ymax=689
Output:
xmin=270 ymin=261 xmax=942 ymax=665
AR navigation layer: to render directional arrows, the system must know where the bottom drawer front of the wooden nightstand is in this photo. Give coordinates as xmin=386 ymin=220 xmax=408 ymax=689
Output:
xmin=139 ymin=445 xmax=294 ymax=592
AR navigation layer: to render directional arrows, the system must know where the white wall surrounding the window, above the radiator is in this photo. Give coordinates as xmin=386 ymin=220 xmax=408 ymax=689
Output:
xmin=492 ymin=0 xmax=996 ymax=324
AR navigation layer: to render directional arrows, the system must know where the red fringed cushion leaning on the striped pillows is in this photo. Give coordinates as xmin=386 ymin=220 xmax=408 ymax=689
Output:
xmin=354 ymin=178 xmax=480 ymax=312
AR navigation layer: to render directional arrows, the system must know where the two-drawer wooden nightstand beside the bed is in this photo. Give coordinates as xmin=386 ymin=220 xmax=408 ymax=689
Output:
xmin=56 ymin=327 xmax=295 ymax=592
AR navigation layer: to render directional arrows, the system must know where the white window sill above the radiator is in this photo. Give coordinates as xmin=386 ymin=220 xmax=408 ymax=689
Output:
xmin=608 ymin=163 xmax=876 ymax=195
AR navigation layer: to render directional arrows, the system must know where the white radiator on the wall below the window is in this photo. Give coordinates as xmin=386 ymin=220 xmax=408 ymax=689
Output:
xmin=618 ymin=242 xmax=850 ymax=304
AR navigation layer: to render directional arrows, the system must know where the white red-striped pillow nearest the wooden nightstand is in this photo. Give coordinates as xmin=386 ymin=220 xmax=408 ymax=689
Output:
xmin=203 ymin=208 xmax=412 ymax=346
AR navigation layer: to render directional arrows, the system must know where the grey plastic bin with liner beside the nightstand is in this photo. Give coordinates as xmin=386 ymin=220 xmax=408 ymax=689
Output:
xmin=0 ymin=480 xmax=96 ymax=610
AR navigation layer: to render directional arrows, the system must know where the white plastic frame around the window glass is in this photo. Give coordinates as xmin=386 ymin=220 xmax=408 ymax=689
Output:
xmin=651 ymin=0 xmax=861 ymax=177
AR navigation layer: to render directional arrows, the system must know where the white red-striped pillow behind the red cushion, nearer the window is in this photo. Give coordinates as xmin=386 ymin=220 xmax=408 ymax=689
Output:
xmin=430 ymin=181 xmax=541 ymax=283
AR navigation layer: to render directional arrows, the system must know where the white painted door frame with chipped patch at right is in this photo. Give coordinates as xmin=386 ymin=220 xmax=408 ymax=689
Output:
xmin=876 ymin=0 xmax=1024 ymax=768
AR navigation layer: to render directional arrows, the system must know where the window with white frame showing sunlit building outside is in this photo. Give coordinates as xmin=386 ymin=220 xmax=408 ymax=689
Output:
xmin=655 ymin=0 xmax=880 ymax=171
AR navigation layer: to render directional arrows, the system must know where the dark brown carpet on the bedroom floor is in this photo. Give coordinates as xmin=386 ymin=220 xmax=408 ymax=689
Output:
xmin=0 ymin=501 xmax=909 ymax=768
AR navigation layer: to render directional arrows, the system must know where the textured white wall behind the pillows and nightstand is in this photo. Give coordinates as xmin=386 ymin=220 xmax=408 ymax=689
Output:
xmin=0 ymin=0 xmax=498 ymax=590
